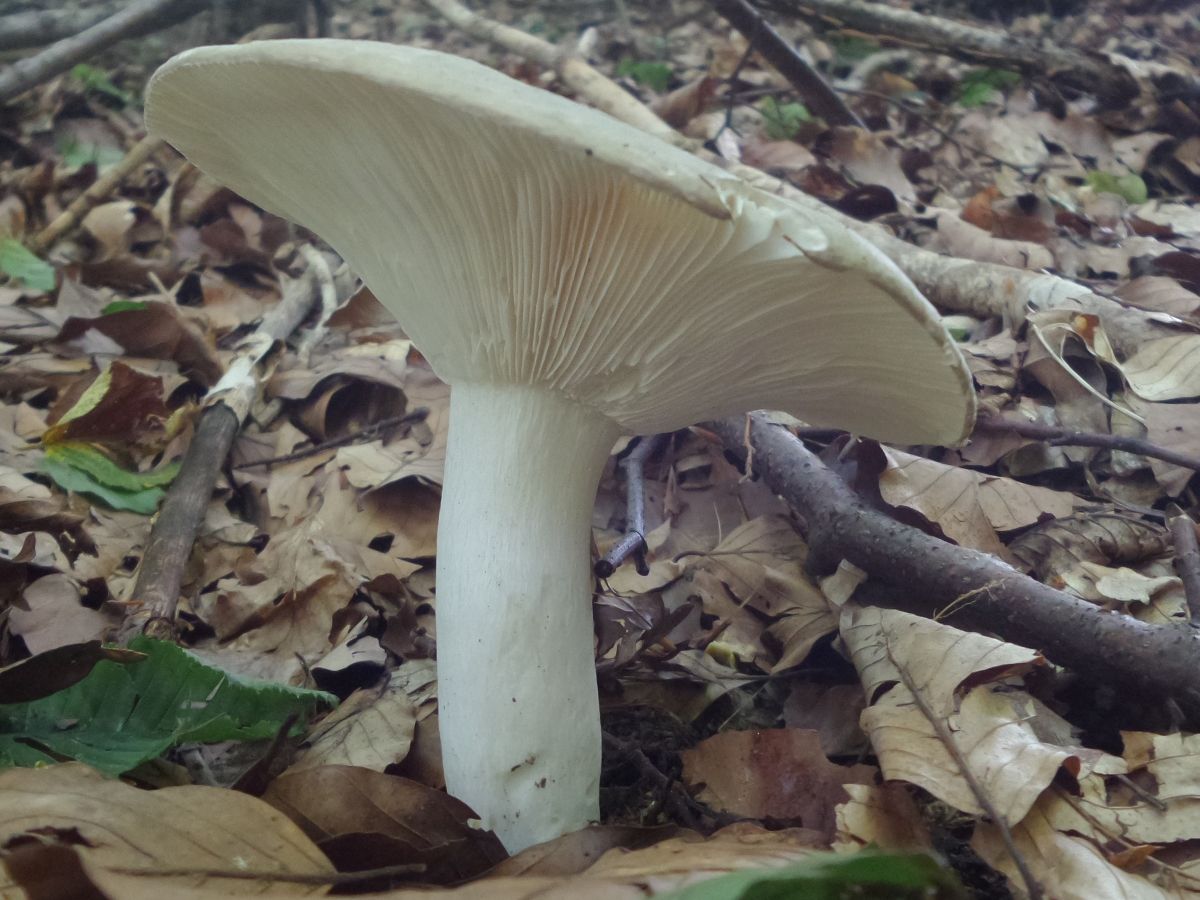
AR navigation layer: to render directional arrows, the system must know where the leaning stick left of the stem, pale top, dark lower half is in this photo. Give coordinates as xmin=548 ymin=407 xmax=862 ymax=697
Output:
xmin=126 ymin=254 xmax=318 ymax=640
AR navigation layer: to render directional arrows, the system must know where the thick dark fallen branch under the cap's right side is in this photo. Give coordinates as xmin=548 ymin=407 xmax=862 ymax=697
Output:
xmin=712 ymin=414 xmax=1200 ymax=720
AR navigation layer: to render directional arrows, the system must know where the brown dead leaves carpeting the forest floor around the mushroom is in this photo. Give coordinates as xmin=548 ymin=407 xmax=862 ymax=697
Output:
xmin=0 ymin=0 xmax=1200 ymax=898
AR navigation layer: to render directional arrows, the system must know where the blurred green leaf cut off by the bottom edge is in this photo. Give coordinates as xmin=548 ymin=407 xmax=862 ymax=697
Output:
xmin=664 ymin=850 xmax=966 ymax=900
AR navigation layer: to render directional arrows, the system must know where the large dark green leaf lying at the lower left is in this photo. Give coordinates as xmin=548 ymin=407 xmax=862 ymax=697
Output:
xmin=0 ymin=637 xmax=337 ymax=775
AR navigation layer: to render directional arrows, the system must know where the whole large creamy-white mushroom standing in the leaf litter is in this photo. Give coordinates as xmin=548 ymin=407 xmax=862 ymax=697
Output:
xmin=146 ymin=40 xmax=974 ymax=852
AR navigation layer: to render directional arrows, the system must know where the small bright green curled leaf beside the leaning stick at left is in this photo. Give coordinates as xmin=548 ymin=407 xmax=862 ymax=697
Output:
xmin=42 ymin=440 xmax=179 ymax=516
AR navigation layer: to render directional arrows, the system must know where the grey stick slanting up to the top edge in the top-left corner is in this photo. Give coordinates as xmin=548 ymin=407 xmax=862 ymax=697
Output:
xmin=0 ymin=0 xmax=206 ymax=102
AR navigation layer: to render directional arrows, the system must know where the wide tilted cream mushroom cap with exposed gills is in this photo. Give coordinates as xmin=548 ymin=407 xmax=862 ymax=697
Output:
xmin=146 ymin=40 xmax=974 ymax=444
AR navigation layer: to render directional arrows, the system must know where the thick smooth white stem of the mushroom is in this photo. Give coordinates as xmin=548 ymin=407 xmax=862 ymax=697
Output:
xmin=437 ymin=383 xmax=619 ymax=852
